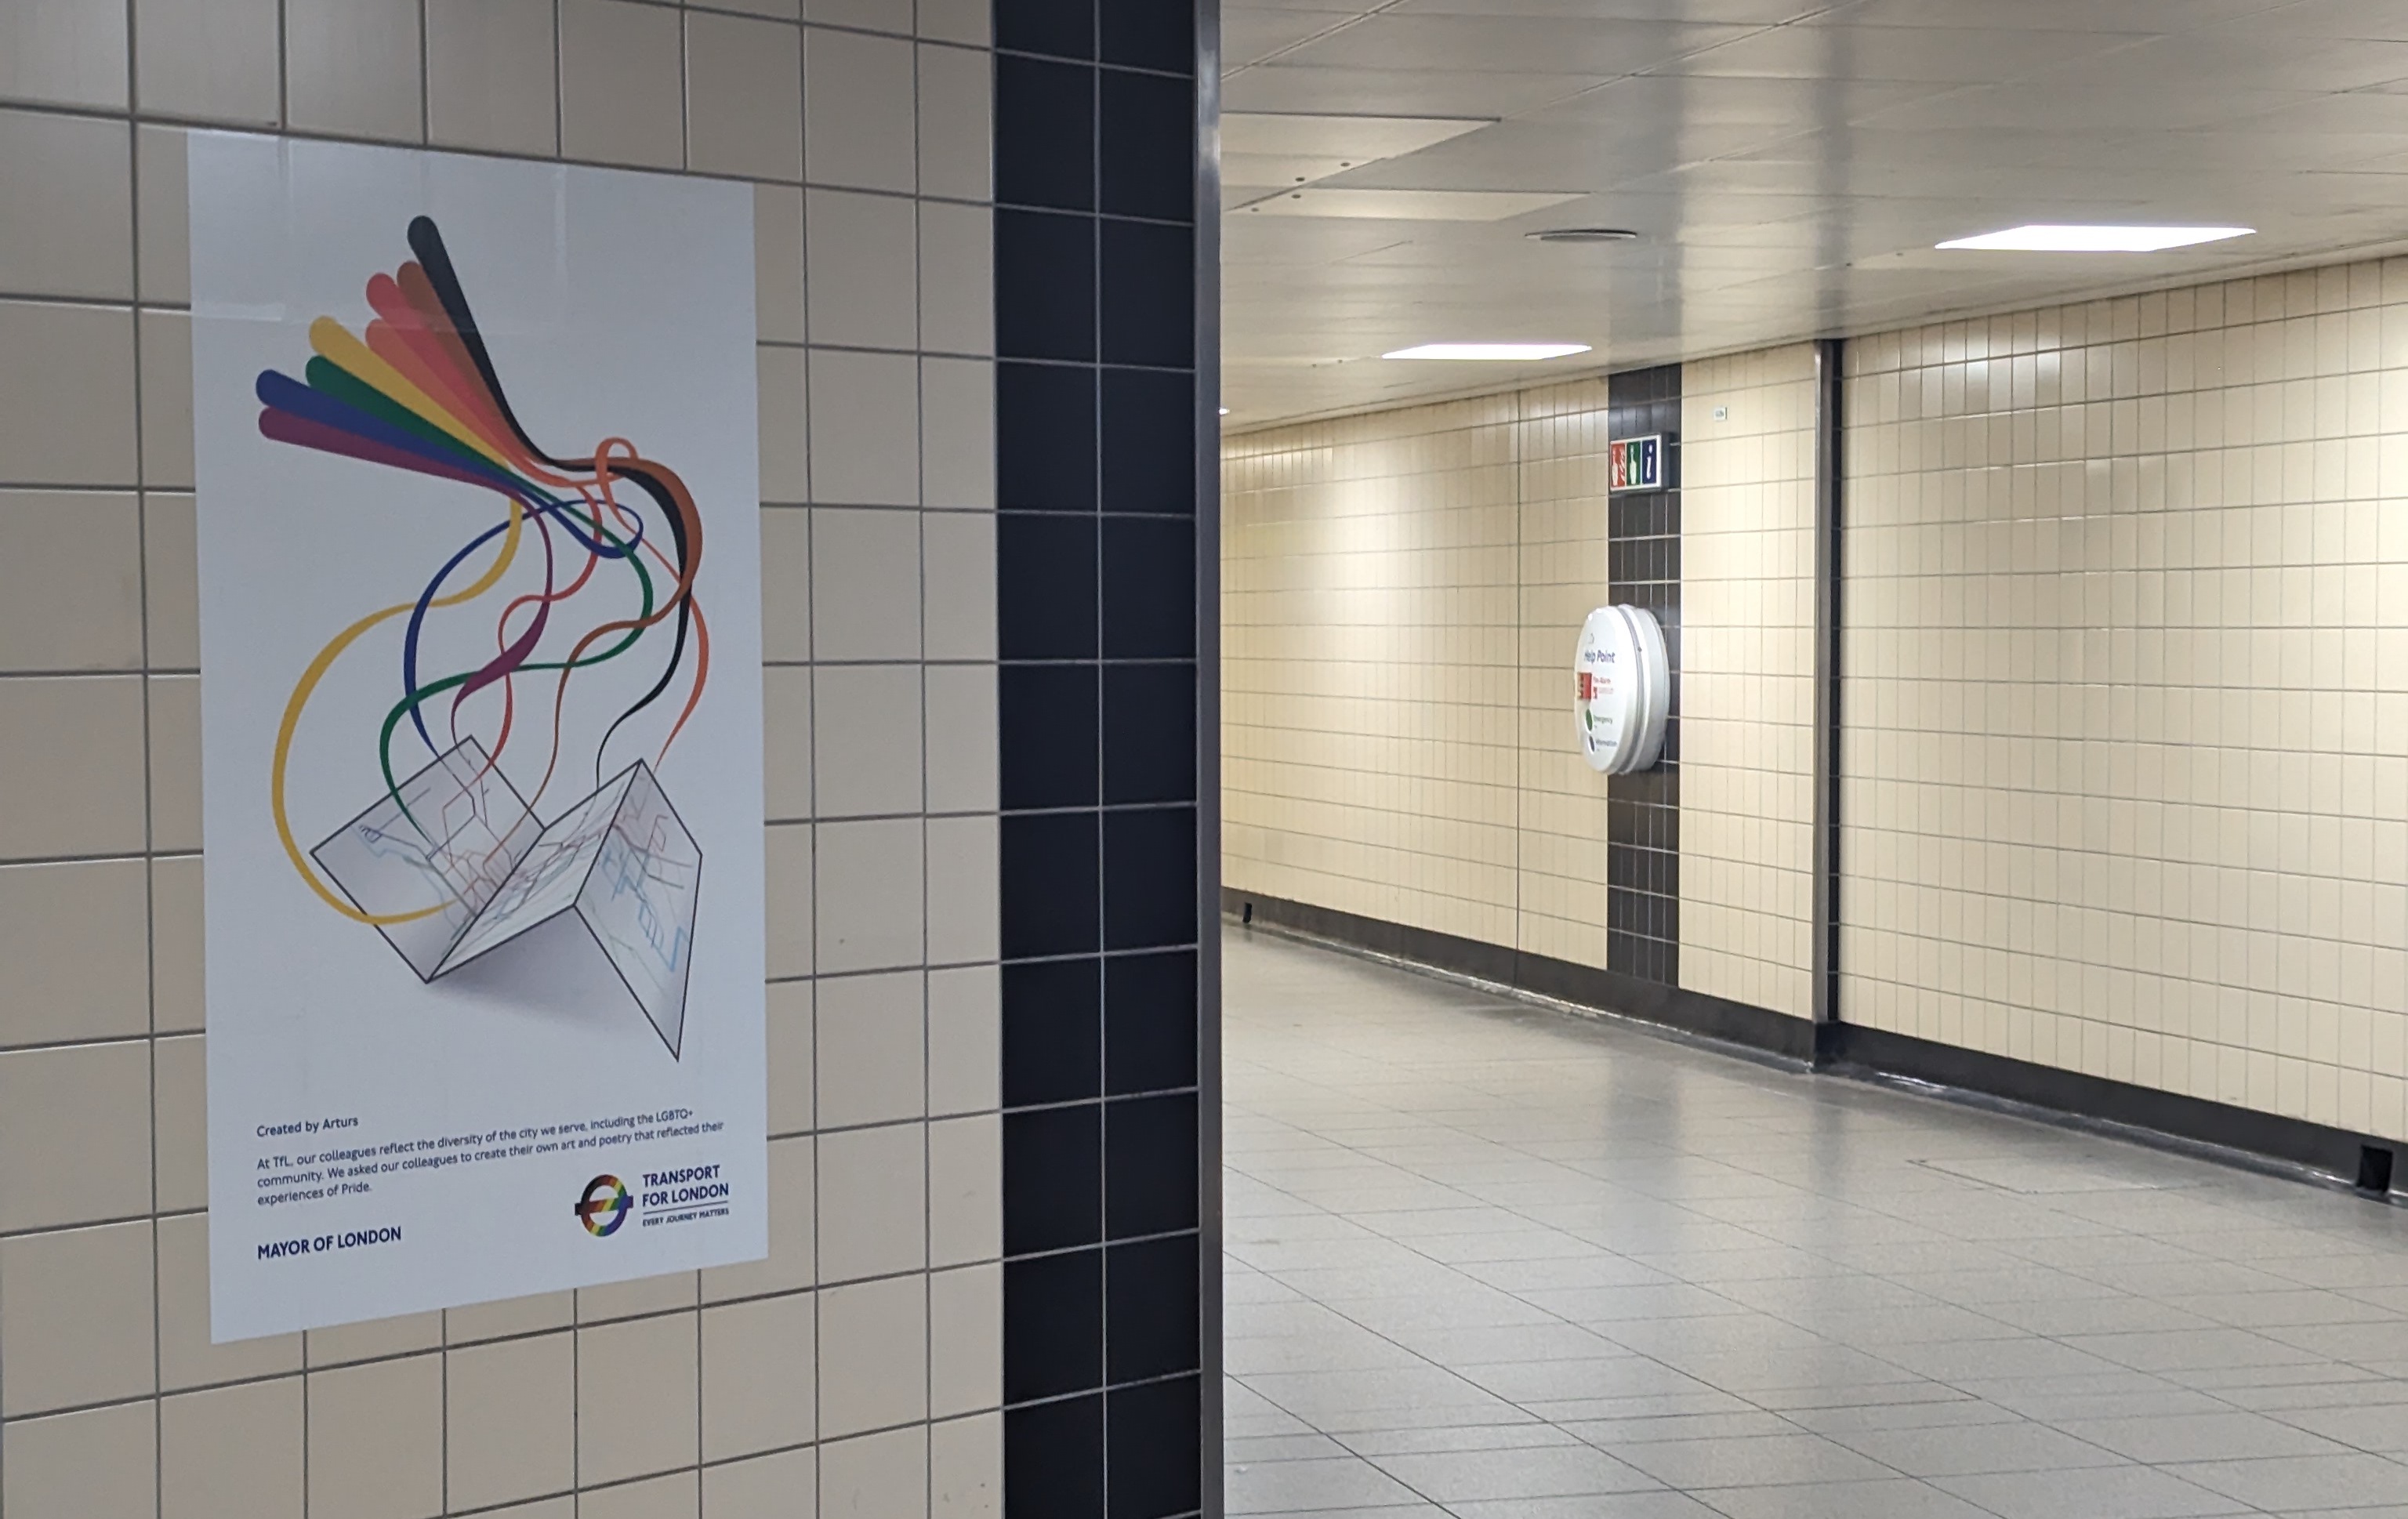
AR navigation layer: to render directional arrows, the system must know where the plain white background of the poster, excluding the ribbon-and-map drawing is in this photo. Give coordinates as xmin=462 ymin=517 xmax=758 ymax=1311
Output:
xmin=190 ymin=132 xmax=768 ymax=1341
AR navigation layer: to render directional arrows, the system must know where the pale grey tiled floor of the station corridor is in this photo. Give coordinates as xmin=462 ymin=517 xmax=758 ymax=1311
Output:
xmin=1226 ymin=932 xmax=2408 ymax=1519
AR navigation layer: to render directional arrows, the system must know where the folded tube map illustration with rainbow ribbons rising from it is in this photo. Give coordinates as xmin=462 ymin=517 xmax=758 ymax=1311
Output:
xmin=256 ymin=216 xmax=710 ymax=1059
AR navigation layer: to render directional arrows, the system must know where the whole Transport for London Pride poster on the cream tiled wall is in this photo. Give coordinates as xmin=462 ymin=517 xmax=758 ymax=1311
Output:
xmin=190 ymin=132 xmax=768 ymax=1341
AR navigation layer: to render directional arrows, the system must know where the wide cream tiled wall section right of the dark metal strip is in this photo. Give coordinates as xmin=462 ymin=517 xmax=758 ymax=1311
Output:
xmin=1840 ymin=263 xmax=2408 ymax=1139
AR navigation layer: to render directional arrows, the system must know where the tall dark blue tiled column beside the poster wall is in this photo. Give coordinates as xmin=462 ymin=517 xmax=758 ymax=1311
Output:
xmin=995 ymin=0 xmax=1218 ymax=1519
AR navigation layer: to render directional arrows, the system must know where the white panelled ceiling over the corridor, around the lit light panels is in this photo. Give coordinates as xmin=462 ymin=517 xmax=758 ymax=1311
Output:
xmin=1224 ymin=0 xmax=2408 ymax=426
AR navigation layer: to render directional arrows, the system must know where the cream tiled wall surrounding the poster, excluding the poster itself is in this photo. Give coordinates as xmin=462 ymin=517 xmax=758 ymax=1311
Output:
xmin=0 ymin=0 xmax=1004 ymax=1519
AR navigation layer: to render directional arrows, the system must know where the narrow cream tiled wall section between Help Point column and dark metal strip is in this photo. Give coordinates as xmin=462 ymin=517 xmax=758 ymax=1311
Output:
xmin=1681 ymin=346 xmax=1815 ymax=1018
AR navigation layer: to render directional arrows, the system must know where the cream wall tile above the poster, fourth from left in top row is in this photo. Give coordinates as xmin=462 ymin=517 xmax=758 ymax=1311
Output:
xmin=426 ymin=0 xmax=561 ymax=159
